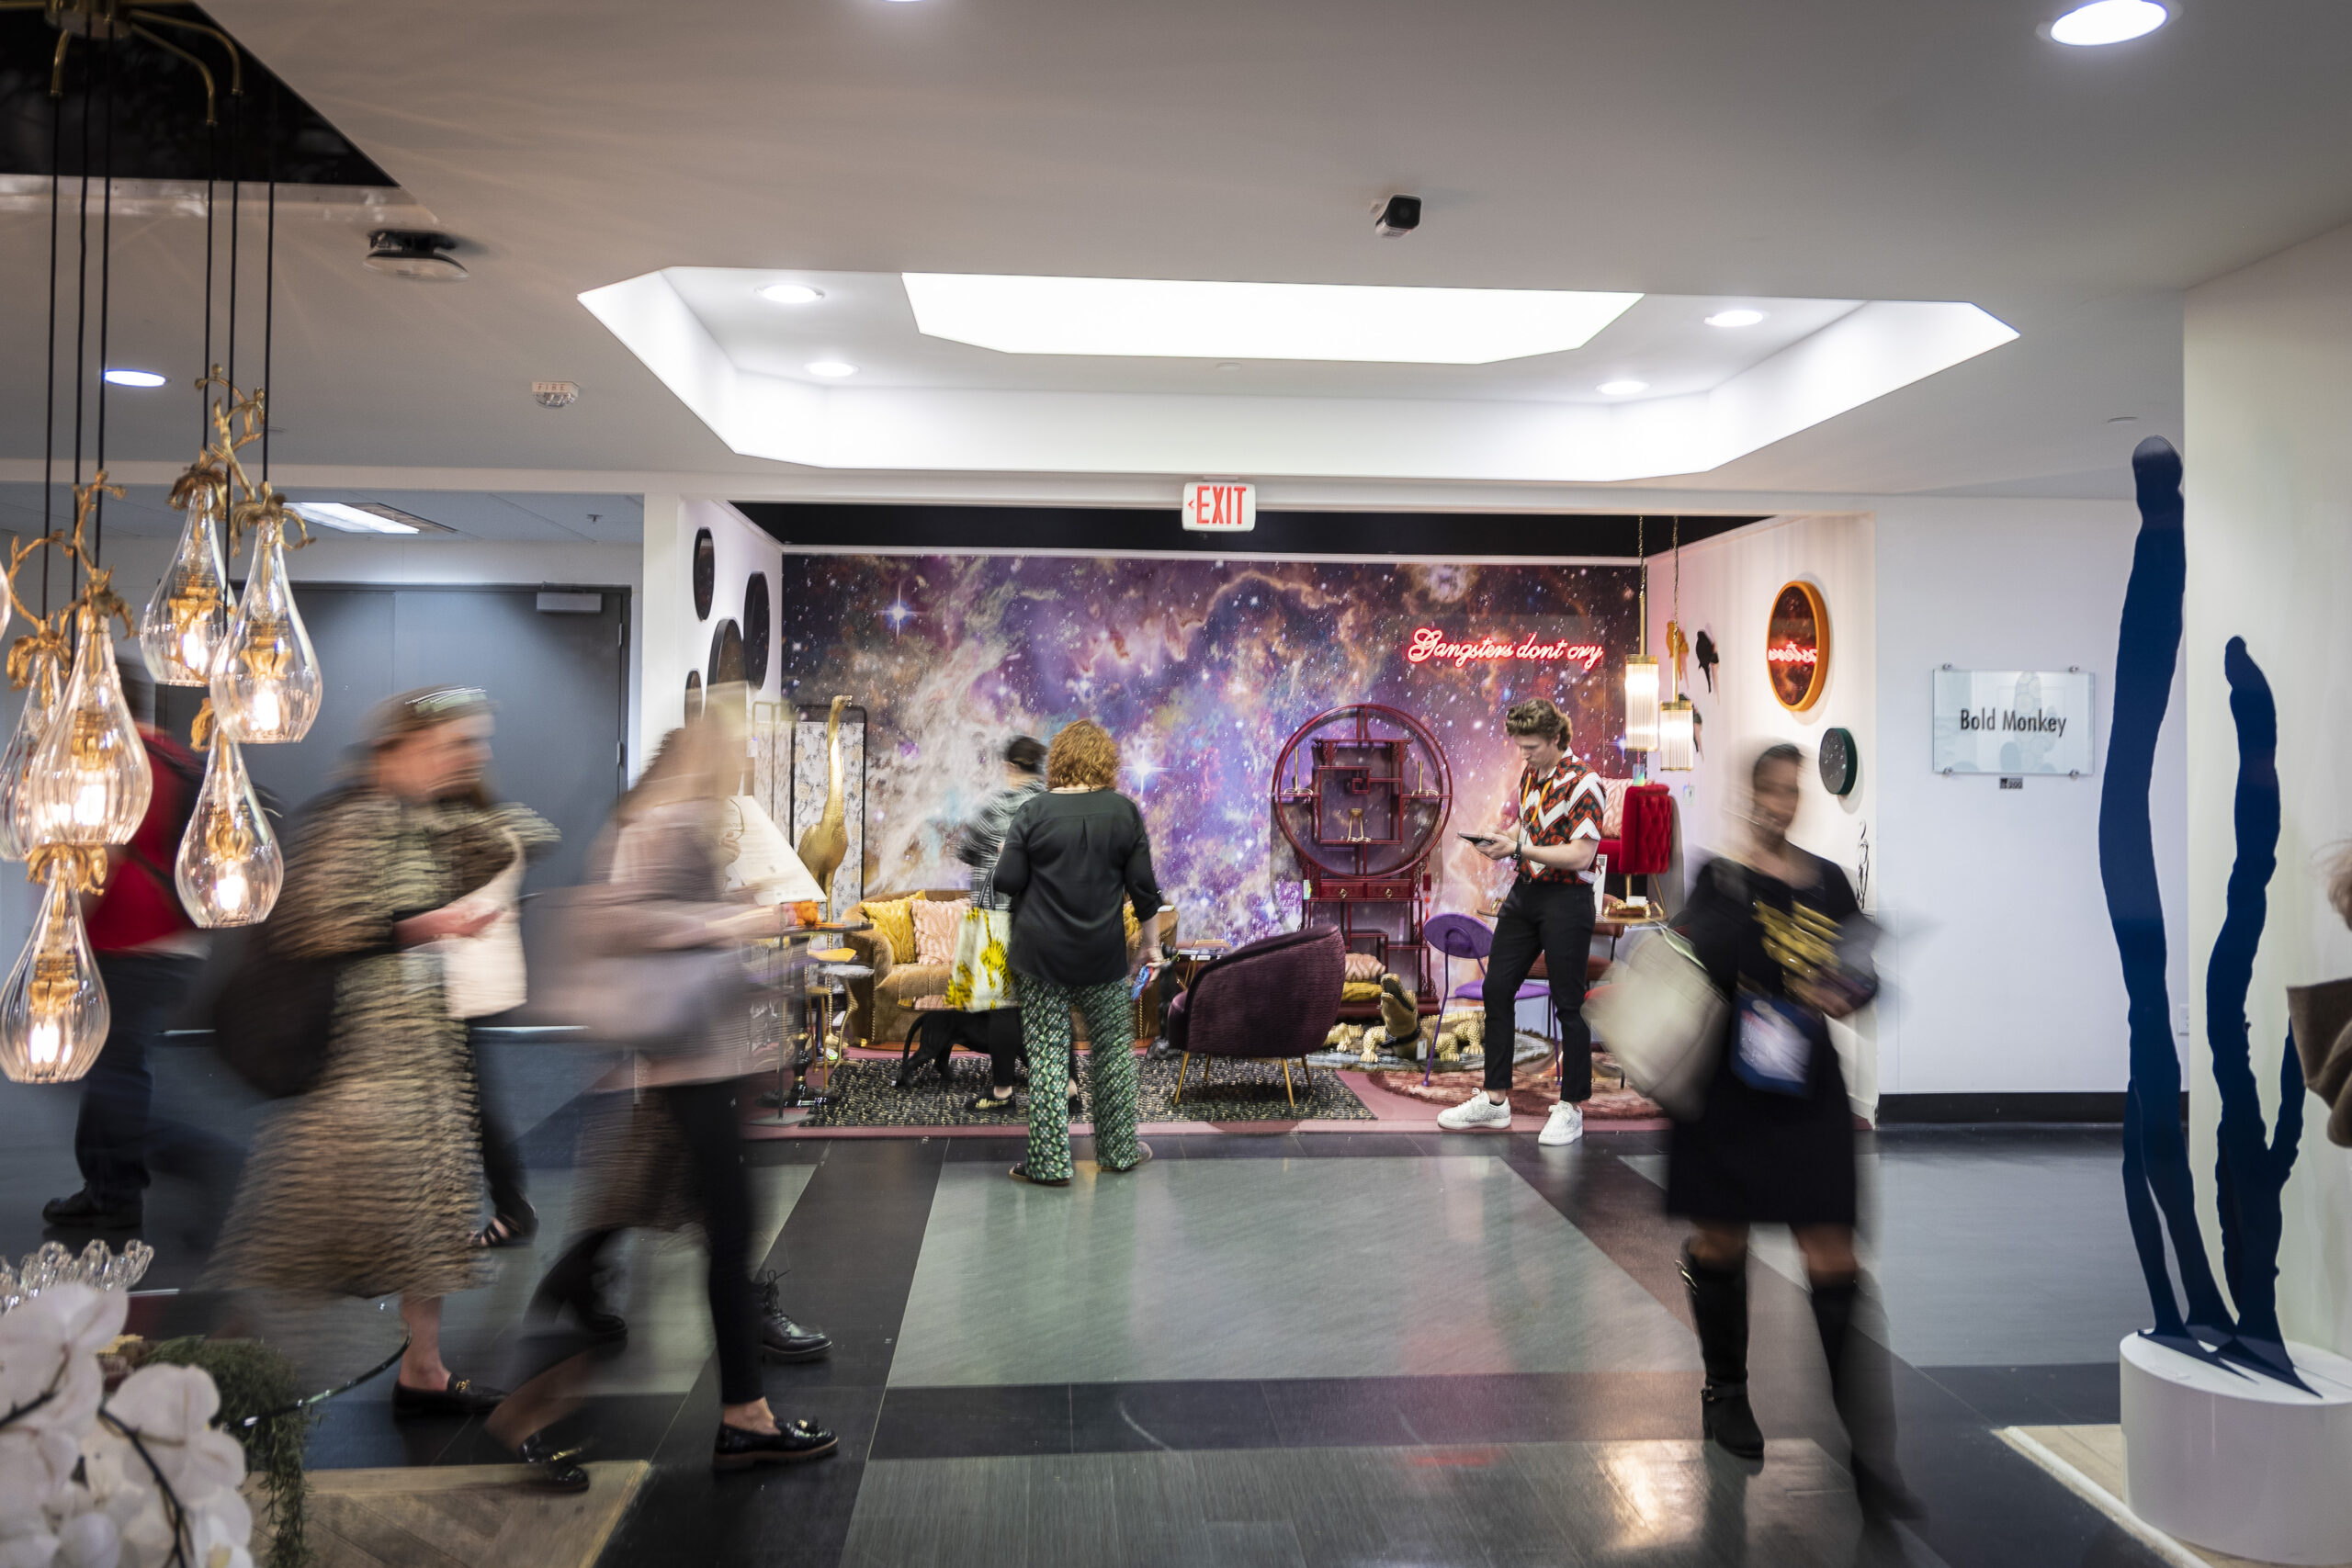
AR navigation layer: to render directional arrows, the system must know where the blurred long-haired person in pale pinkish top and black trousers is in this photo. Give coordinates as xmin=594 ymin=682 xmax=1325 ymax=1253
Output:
xmin=522 ymin=696 xmax=837 ymax=1485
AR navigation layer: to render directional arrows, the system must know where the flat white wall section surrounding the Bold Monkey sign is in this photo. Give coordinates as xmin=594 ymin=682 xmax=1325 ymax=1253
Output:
xmin=1872 ymin=502 xmax=2188 ymax=1093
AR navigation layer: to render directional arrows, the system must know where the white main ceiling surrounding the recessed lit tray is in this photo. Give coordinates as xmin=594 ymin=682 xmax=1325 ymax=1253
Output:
xmin=0 ymin=0 xmax=2352 ymax=501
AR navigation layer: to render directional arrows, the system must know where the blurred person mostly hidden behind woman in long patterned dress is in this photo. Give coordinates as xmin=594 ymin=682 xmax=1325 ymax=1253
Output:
xmin=433 ymin=773 xmax=562 ymax=1246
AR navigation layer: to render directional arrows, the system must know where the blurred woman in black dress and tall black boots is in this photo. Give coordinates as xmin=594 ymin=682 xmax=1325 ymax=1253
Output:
xmin=1665 ymin=743 xmax=1917 ymax=1517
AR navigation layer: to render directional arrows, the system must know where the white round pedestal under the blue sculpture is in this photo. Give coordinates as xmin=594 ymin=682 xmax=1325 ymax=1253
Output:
xmin=2121 ymin=1336 xmax=2352 ymax=1563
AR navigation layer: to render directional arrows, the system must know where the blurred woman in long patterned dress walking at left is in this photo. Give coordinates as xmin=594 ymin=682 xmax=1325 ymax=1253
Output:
xmin=209 ymin=686 xmax=514 ymax=1416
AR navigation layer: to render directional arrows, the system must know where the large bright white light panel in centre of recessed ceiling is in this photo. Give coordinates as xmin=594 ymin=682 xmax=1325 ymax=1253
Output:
xmin=906 ymin=273 xmax=1642 ymax=365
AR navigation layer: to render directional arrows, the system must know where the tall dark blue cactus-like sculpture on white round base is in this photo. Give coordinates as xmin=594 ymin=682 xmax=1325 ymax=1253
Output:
xmin=2098 ymin=437 xmax=2302 ymax=1387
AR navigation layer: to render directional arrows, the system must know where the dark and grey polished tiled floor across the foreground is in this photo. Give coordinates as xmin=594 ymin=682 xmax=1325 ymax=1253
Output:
xmin=0 ymin=1046 xmax=2154 ymax=1568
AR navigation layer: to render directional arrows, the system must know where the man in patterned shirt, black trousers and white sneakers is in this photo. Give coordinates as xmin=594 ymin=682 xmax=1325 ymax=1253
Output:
xmin=1437 ymin=698 xmax=1601 ymax=1145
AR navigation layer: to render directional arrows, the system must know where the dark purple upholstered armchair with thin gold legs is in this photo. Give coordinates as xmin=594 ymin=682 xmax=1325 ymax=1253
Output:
xmin=1162 ymin=926 xmax=1348 ymax=1105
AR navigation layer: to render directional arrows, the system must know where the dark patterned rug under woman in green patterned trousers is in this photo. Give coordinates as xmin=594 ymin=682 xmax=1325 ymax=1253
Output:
xmin=805 ymin=1054 xmax=1374 ymax=1128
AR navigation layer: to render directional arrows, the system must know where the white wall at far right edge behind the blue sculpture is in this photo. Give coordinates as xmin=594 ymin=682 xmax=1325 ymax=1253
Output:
xmin=2183 ymin=217 xmax=2352 ymax=1352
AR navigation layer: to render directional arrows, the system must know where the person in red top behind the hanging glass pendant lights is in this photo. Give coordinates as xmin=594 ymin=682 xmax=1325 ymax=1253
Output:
xmin=40 ymin=653 xmax=209 ymax=1229
